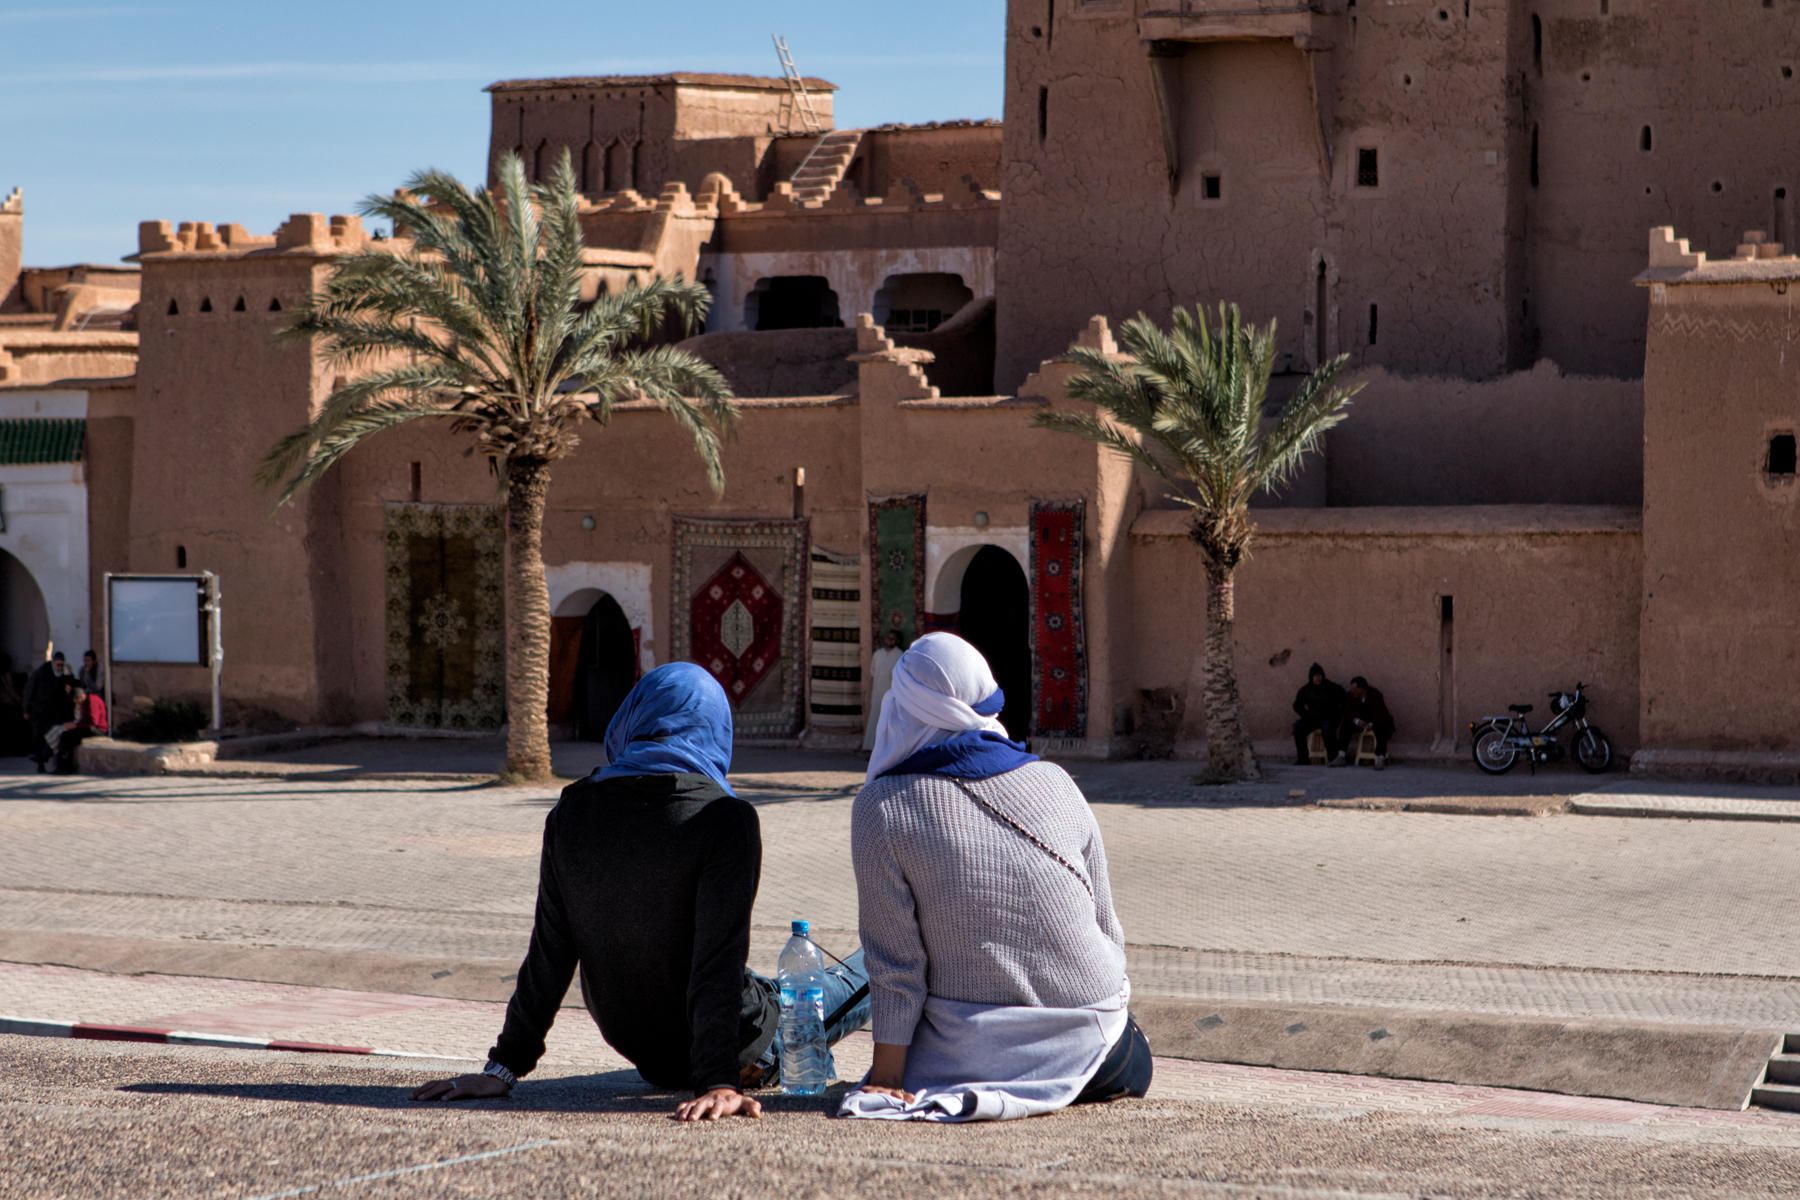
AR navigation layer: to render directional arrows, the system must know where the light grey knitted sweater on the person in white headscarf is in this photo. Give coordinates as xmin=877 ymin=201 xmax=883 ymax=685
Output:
xmin=850 ymin=763 xmax=1125 ymax=1045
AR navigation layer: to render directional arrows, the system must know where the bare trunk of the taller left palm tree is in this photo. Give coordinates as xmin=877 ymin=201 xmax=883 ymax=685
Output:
xmin=506 ymin=459 xmax=553 ymax=781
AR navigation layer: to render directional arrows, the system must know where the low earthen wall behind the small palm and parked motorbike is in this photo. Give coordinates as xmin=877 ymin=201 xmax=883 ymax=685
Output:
xmin=1130 ymin=506 xmax=1643 ymax=754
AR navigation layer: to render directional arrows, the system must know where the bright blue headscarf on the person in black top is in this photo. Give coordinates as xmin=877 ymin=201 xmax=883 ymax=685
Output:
xmin=589 ymin=662 xmax=736 ymax=795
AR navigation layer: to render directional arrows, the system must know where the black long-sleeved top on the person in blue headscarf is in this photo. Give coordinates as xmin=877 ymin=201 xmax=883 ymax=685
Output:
xmin=490 ymin=775 xmax=779 ymax=1092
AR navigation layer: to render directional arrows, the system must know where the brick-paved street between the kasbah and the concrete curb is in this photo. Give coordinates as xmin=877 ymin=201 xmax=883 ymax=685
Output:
xmin=10 ymin=752 xmax=1800 ymax=1029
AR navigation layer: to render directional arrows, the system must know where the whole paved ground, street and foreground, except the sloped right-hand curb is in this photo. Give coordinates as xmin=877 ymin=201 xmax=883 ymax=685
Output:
xmin=0 ymin=743 xmax=1800 ymax=1196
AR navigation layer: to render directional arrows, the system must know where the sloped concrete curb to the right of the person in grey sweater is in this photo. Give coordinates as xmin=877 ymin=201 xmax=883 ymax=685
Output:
xmin=1132 ymin=997 xmax=1784 ymax=1112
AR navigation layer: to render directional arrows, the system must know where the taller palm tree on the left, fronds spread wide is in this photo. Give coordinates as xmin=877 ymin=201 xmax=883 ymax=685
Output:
xmin=257 ymin=153 xmax=736 ymax=779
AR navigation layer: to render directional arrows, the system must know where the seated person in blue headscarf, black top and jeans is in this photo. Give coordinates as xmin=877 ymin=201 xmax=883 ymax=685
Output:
xmin=412 ymin=662 xmax=868 ymax=1121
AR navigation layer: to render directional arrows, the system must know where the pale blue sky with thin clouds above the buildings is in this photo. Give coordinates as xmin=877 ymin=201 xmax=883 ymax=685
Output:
xmin=0 ymin=0 xmax=1006 ymax=266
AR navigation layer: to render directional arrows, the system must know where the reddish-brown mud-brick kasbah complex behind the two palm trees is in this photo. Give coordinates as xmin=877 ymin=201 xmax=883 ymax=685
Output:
xmin=0 ymin=0 xmax=1800 ymax=781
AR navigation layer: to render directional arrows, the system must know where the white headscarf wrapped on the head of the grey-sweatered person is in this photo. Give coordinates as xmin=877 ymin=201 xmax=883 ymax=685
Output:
xmin=868 ymin=633 xmax=1006 ymax=779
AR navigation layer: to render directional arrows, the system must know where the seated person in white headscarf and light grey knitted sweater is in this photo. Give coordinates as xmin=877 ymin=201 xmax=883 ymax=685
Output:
xmin=839 ymin=633 xmax=1152 ymax=1121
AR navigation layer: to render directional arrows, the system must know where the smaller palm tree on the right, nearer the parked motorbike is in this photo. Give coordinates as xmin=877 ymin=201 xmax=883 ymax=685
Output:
xmin=1035 ymin=304 xmax=1363 ymax=779
